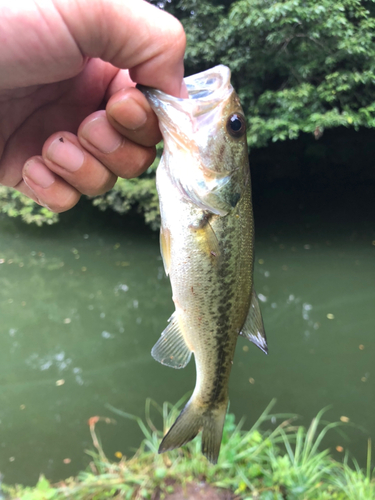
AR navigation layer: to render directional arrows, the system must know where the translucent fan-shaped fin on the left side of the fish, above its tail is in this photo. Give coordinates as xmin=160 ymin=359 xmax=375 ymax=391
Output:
xmin=151 ymin=312 xmax=191 ymax=369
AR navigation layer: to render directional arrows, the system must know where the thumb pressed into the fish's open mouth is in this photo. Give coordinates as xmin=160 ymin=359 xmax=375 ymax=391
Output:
xmin=54 ymin=0 xmax=186 ymax=97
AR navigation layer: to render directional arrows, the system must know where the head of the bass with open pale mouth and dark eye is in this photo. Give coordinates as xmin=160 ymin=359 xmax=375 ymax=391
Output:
xmin=141 ymin=65 xmax=250 ymax=216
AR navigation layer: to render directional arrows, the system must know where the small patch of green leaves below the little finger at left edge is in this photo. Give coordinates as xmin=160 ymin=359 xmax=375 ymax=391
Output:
xmin=0 ymin=185 xmax=58 ymax=226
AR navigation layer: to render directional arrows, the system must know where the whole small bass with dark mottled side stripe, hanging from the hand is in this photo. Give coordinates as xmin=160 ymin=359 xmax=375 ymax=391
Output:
xmin=141 ymin=65 xmax=267 ymax=463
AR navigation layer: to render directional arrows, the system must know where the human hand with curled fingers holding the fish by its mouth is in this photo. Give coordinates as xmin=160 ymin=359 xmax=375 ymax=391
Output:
xmin=0 ymin=0 xmax=187 ymax=212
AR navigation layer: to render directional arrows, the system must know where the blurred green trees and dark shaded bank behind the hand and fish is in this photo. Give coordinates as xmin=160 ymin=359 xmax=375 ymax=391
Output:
xmin=0 ymin=0 xmax=375 ymax=229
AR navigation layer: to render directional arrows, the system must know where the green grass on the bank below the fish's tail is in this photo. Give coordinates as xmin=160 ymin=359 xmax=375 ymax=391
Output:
xmin=0 ymin=400 xmax=375 ymax=500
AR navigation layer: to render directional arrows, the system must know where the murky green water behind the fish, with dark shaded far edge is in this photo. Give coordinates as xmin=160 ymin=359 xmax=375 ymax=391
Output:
xmin=0 ymin=186 xmax=375 ymax=484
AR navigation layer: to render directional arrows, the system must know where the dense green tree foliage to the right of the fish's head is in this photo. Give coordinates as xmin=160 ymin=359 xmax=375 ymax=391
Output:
xmin=166 ymin=0 xmax=375 ymax=147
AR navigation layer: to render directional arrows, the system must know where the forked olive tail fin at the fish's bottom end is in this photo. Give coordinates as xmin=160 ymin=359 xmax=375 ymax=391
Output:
xmin=159 ymin=399 xmax=228 ymax=464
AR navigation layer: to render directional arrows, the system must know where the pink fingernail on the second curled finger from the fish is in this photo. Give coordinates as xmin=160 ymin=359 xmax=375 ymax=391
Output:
xmin=81 ymin=116 xmax=122 ymax=153
